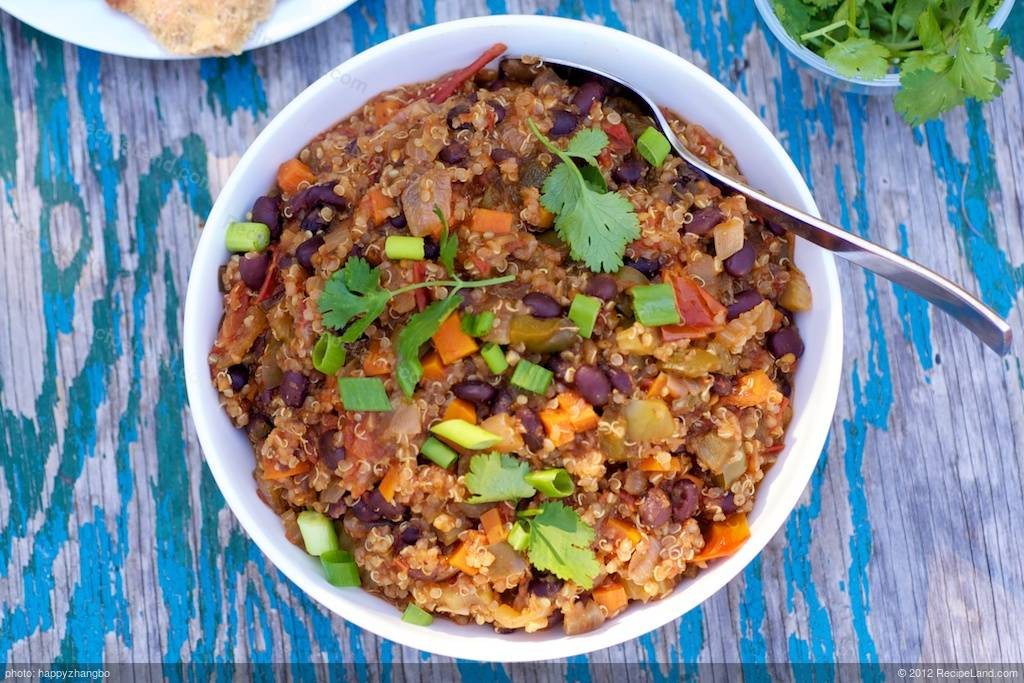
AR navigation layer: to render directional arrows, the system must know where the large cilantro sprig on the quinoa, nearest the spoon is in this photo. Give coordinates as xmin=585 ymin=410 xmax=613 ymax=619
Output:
xmin=526 ymin=119 xmax=640 ymax=272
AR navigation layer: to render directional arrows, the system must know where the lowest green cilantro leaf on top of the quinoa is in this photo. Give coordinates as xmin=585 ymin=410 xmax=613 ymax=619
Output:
xmin=528 ymin=503 xmax=601 ymax=590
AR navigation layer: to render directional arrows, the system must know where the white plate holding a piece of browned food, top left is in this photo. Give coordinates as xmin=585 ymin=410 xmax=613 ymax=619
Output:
xmin=0 ymin=0 xmax=355 ymax=59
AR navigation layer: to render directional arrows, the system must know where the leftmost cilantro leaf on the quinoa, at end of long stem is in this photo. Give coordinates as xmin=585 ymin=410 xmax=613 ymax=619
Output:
xmin=318 ymin=257 xmax=391 ymax=331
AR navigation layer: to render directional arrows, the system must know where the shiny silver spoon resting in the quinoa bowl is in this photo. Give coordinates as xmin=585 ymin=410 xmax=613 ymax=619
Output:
xmin=544 ymin=58 xmax=1013 ymax=355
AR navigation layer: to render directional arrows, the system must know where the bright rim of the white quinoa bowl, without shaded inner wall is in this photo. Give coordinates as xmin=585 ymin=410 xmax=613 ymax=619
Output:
xmin=182 ymin=15 xmax=843 ymax=661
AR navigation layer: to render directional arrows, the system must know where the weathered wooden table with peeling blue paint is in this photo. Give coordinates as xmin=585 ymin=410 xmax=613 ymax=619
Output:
xmin=0 ymin=0 xmax=1024 ymax=680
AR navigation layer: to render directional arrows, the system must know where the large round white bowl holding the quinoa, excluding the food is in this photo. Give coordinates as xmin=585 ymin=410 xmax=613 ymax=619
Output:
xmin=184 ymin=16 xmax=843 ymax=661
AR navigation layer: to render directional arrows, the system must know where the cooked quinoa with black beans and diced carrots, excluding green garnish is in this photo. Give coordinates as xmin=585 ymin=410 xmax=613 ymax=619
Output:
xmin=210 ymin=46 xmax=810 ymax=635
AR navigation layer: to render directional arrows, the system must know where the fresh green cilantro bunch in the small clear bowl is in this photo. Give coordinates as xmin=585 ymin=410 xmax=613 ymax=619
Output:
xmin=774 ymin=0 xmax=1010 ymax=125
